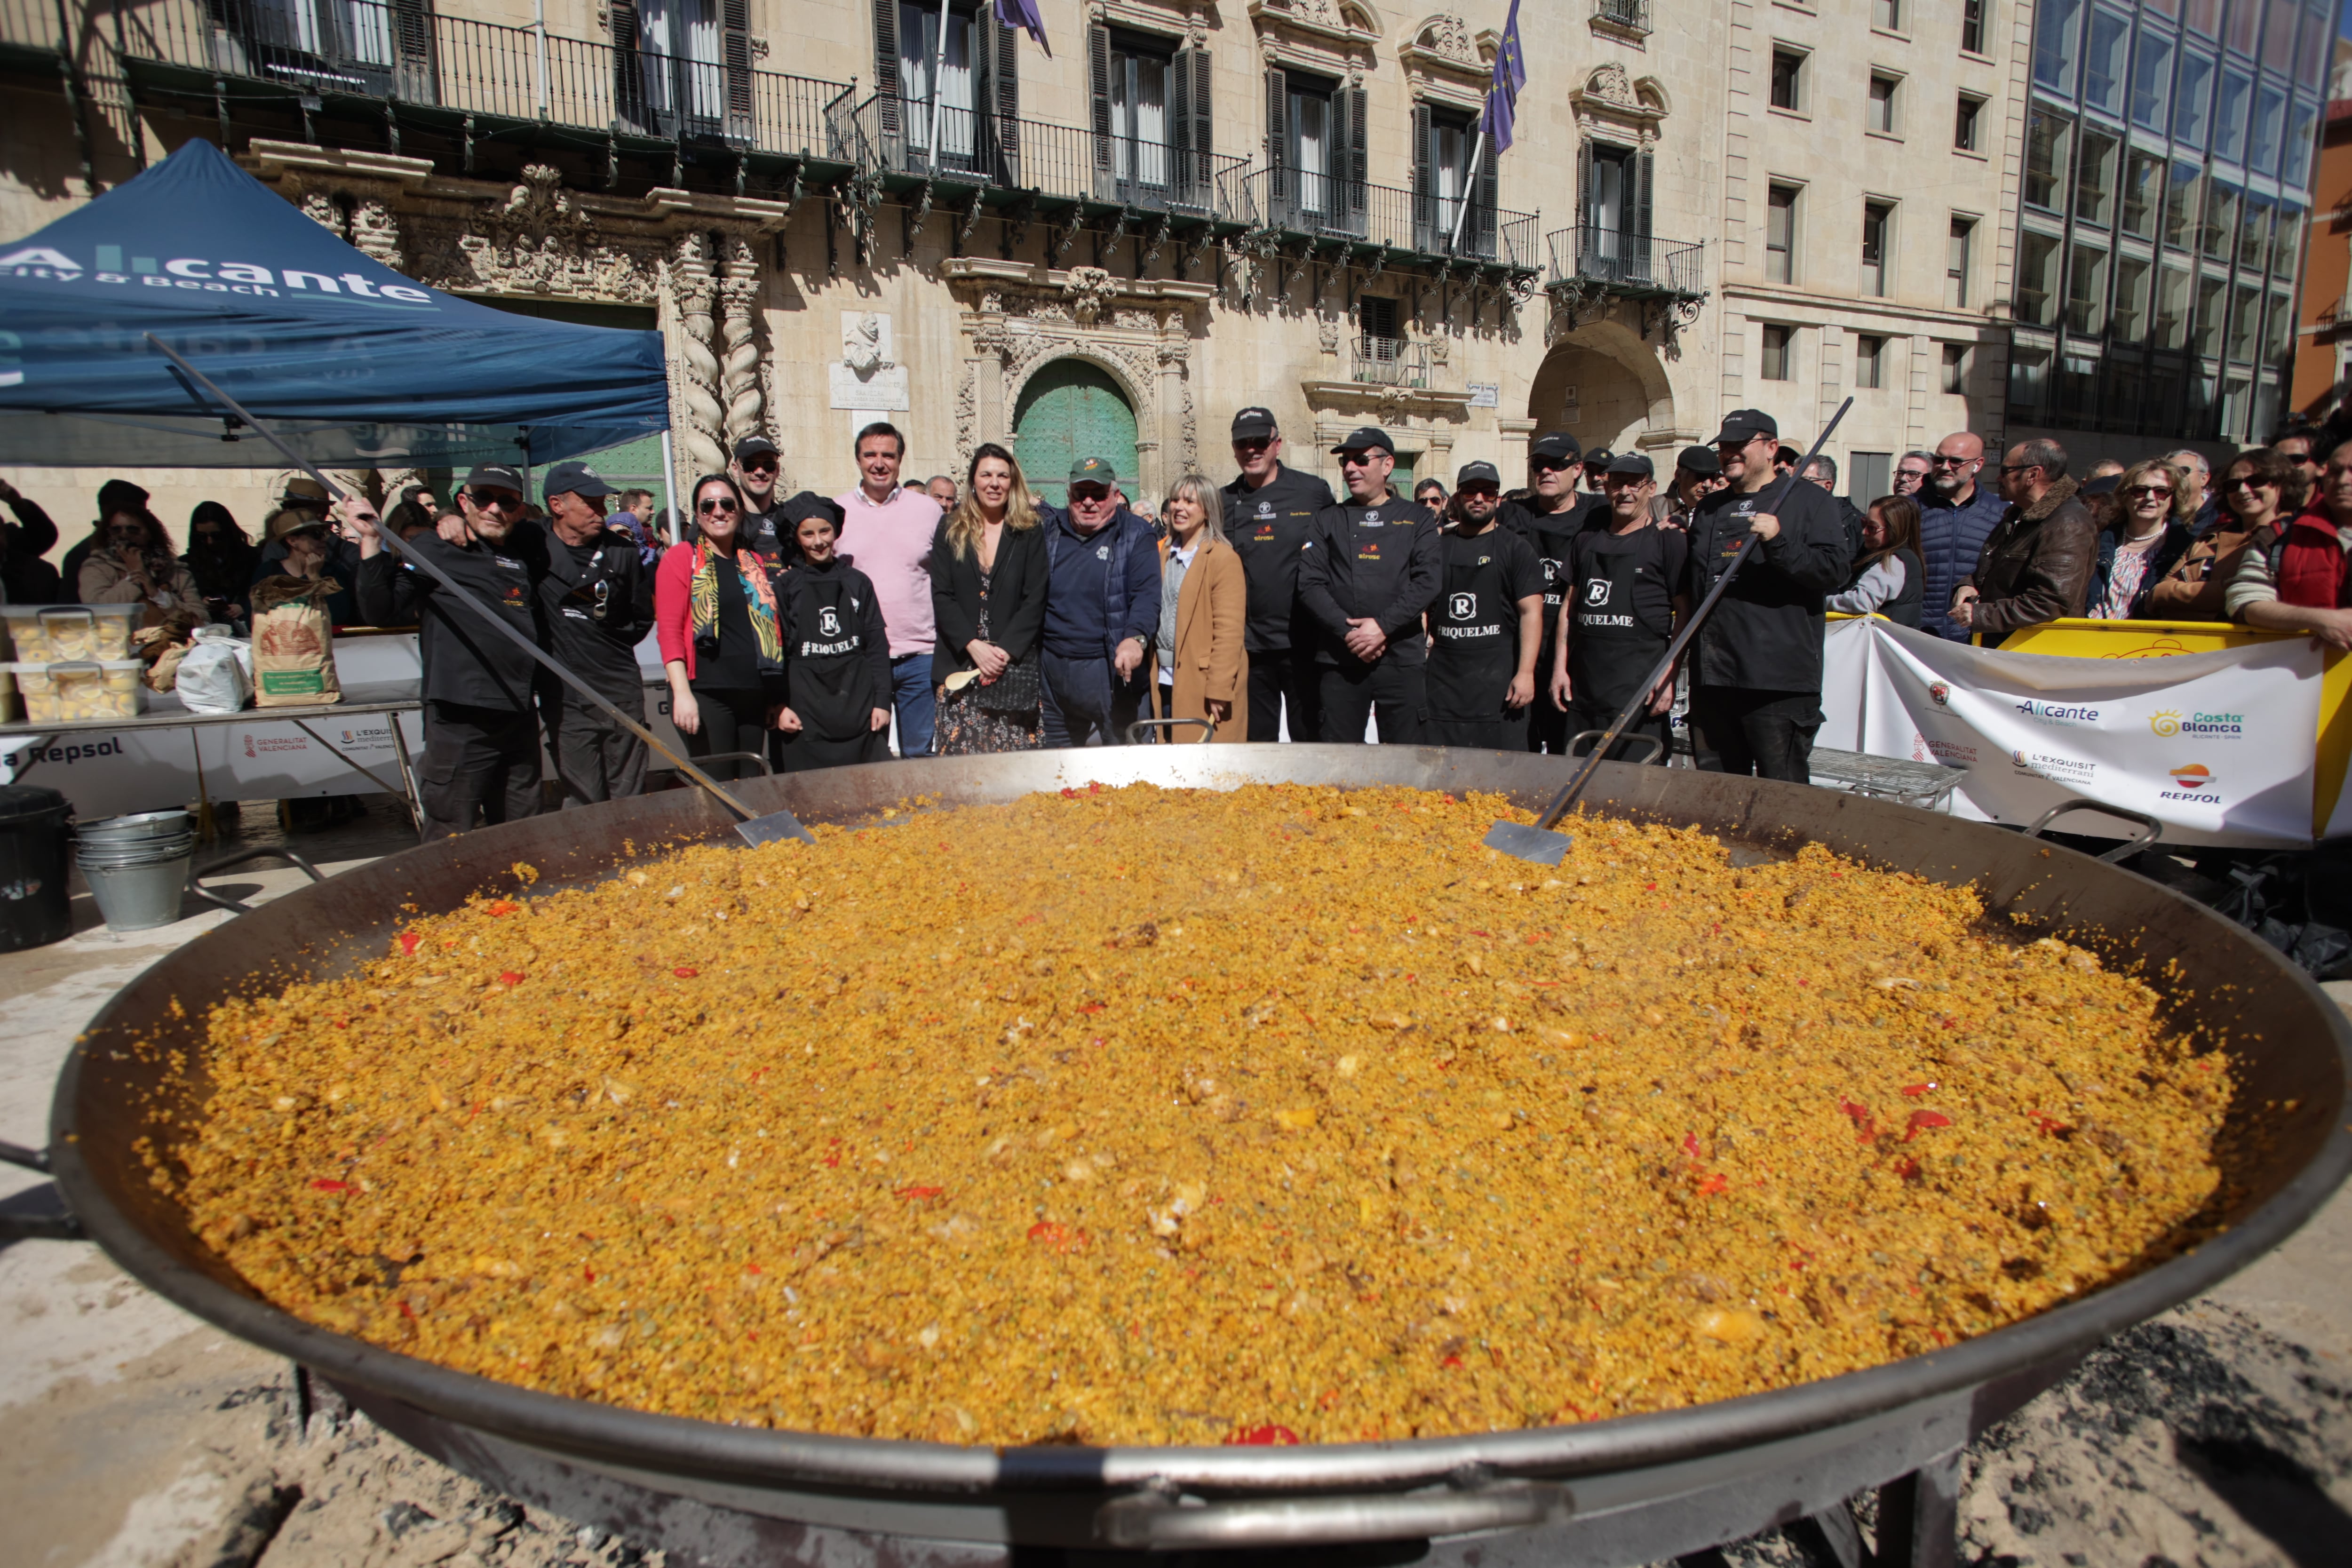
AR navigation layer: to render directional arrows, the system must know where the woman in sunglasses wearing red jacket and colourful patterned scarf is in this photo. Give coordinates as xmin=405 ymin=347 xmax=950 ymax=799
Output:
xmin=654 ymin=475 xmax=783 ymax=783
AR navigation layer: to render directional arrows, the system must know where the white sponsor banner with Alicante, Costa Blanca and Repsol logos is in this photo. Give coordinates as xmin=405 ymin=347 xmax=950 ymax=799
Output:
xmin=1820 ymin=621 xmax=2324 ymax=846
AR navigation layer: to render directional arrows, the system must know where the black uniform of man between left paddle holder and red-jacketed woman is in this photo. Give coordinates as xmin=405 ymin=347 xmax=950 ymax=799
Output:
xmin=539 ymin=522 xmax=654 ymax=804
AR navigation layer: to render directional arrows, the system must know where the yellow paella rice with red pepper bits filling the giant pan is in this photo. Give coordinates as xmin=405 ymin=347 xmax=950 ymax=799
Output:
xmin=174 ymin=785 xmax=2232 ymax=1443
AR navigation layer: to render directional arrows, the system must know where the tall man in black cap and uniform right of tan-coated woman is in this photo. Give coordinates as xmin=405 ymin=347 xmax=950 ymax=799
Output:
xmin=1221 ymin=409 xmax=1331 ymax=740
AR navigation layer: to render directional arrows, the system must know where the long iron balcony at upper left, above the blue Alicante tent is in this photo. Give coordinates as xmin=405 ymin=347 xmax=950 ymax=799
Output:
xmin=112 ymin=0 xmax=849 ymax=165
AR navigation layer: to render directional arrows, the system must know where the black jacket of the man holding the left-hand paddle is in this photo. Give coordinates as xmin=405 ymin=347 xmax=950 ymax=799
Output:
xmin=358 ymin=526 xmax=548 ymax=712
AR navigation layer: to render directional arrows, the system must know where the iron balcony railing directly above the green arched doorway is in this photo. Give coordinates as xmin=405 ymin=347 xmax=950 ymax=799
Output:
xmin=851 ymin=94 xmax=1249 ymax=221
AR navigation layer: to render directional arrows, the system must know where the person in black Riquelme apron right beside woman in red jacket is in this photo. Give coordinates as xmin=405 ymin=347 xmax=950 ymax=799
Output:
xmin=776 ymin=512 xmax=891 ymax=773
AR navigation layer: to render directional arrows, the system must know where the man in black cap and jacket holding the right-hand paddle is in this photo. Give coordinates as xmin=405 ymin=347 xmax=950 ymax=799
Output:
xmin=1684 ymin=409 xmax=1851 ymax=783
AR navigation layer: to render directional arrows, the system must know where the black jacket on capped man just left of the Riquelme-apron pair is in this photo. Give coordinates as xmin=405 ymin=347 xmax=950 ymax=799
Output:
xmin=1298 ymin=496 xmax=1444 ymax=665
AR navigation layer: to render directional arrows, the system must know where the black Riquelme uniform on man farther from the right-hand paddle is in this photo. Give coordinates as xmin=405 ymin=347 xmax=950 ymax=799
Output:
xmin=1423 ymin=524 xmax=1550 ymax=752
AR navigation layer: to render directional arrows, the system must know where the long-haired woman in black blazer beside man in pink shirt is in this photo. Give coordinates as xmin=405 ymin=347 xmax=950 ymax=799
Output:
xmin=929 ymin=442 xmax=1047 ymax=757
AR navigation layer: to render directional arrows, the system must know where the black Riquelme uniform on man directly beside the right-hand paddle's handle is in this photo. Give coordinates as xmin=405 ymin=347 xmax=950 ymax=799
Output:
xmin=1566 ymin=522 xmax=1689 ymax=764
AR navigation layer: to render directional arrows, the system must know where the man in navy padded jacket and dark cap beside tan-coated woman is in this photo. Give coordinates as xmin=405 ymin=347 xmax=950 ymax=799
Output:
xmin=1037 ymin=458 xmax=1160 ymax=745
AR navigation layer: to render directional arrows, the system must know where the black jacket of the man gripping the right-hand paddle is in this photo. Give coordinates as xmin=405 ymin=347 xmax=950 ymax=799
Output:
xmin=1689 ymin=479 xmax=1853 ymax=691
